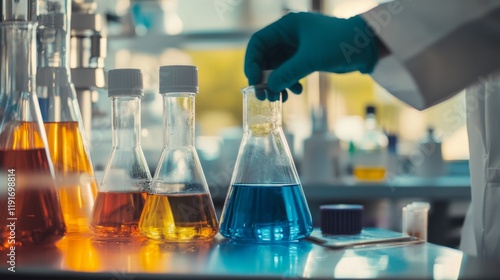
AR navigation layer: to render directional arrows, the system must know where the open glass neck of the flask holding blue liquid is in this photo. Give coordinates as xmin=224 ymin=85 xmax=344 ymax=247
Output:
xmin=242 ymin=86 xmax=282 ymax=135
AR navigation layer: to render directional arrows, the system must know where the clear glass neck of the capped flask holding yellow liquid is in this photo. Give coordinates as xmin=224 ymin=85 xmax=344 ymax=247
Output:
xmin=163 ymin=92 xmax=195 ymax=148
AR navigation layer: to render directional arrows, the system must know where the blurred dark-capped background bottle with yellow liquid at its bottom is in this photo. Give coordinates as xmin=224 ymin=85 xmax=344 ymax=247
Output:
xmin=353 ymin=105 xmax=388 ymax=181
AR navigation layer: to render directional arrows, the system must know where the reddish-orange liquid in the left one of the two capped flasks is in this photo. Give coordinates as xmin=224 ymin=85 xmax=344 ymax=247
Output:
xmin=90 ymin=192 xmax=147 ymax=237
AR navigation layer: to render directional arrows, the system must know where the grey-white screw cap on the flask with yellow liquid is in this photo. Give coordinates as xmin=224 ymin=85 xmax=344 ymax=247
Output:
xmin=160 ymin=65 xmax=198 ymax=94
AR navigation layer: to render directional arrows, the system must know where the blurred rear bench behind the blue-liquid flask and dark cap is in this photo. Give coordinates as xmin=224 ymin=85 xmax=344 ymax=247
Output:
xmin=207 ymin=175 xmax=471 ymax=248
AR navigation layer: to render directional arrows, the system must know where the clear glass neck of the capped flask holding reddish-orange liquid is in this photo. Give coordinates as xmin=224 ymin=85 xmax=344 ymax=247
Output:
xmin=112 ymin=96 xmax=141 ymax=149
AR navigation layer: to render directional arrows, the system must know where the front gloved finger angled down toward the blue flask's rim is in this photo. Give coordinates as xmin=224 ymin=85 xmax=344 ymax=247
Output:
xmin=267 ymin=53 xmax=313 ymax=92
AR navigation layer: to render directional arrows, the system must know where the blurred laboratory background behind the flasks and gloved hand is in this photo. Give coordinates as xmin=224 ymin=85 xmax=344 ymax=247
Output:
xmin=84 ymin=0 xmax=470 ymax=247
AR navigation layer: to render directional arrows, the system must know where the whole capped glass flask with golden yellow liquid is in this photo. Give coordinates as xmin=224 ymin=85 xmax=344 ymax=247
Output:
xmin=139 ymin=65 xmax=219 ymax=242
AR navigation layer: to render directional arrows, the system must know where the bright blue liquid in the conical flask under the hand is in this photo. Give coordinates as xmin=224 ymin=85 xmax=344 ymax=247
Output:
xmin=220 ymin=184 xmax=313 ymax=242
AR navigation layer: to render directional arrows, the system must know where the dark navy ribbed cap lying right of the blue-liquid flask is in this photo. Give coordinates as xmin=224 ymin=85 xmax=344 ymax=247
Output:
xmin=319 ymin=204 xmax=363 ymax=235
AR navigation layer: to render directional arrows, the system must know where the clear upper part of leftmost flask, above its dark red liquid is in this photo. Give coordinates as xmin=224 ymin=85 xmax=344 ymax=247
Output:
xmin=0 ymin=22 xmax=52 ymax=152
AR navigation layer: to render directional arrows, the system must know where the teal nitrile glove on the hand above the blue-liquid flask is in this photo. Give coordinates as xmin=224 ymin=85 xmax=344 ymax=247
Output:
xmin=245 ymin=12 xmax=378 ymax=101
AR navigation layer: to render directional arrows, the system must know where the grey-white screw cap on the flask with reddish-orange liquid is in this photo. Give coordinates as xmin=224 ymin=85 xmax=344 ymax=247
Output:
xmin=108 ymin=69 xmax=144 ymax=97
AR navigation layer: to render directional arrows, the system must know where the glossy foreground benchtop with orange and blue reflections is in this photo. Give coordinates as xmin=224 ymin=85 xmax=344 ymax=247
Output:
xmin=0 ymin=229 xmax=500 ymax=280
